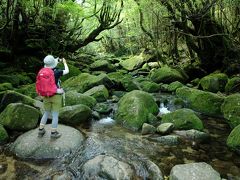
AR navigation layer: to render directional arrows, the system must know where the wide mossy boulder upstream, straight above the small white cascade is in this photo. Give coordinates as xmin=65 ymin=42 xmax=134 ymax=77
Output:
xmin=150 ymin=66 xmax=186 ymax=84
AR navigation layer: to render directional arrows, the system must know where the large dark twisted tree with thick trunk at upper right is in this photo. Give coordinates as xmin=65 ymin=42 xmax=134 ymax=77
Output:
xmin=159 ymin=0 xmax=240 ymax=73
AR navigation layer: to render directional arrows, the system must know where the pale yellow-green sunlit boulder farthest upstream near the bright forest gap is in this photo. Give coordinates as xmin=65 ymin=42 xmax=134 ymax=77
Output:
xmin=120 ymin=53 xmax=151 ymax=71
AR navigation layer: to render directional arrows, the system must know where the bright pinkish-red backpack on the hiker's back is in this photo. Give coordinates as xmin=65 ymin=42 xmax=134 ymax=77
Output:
xmin=36 ymin=68 xmax=57 ymax=97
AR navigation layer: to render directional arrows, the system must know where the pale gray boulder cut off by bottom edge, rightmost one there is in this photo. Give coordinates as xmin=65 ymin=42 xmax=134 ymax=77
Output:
xmin=170 ymin=162 xmax=221 ymax=180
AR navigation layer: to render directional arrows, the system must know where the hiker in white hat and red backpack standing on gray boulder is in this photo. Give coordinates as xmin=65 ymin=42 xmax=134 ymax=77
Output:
xmin=36 ymin=55 xmax=69 ymax=138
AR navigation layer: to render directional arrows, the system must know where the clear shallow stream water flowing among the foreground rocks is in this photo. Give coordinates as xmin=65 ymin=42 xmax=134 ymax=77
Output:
xmin=0 ymin=93 xmax=240 ymax=180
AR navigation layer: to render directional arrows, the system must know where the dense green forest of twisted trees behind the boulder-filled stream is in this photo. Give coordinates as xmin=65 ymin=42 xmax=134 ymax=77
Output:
xmin=0 ymin=0 xmax=240 ymax=77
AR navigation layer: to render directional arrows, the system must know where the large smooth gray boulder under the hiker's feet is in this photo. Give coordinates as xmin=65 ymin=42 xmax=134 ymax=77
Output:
xmin=11 ymin=125 xmax=84 ymax=159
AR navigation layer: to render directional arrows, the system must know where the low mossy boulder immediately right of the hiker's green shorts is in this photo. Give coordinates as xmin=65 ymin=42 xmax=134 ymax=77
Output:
xmin=65 ymin=91 xmax=97 ymax=108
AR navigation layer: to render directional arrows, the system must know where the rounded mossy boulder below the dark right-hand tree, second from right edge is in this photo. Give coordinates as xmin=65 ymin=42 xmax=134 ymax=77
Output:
xmin=200 ymin=73 xmax=228 ymax=93
